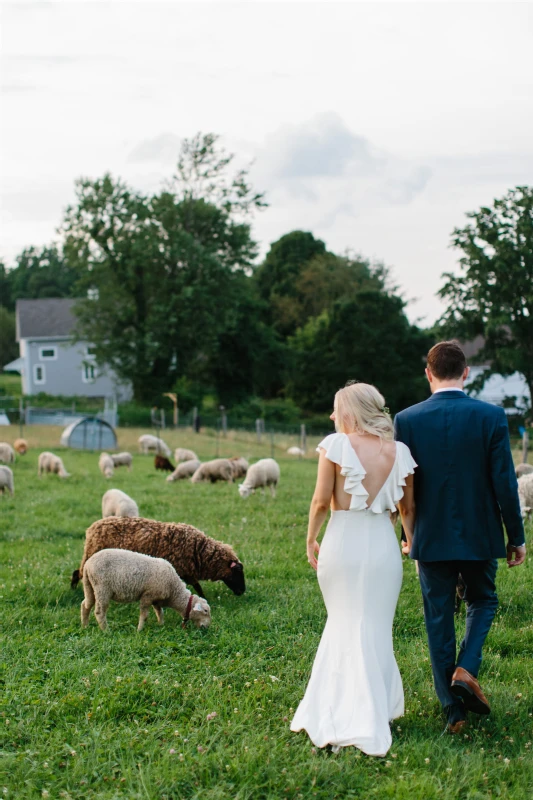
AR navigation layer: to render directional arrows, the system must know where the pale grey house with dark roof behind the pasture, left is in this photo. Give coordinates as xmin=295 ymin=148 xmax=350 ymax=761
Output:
xmin=4 ymin=298 xmax=131 ymax=400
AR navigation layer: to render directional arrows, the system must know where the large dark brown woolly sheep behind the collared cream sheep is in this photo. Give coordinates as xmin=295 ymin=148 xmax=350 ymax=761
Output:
xmin=70 ymin=517 xmax=246 ymax=597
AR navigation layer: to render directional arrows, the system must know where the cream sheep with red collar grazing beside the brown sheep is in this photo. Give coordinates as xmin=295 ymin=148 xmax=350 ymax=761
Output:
xmin=81 ymin=549 xmax=211 ymax=631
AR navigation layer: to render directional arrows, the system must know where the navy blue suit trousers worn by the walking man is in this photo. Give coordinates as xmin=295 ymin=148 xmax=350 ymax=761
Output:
xmin=418 ymin=559 xmax=498 ymax=723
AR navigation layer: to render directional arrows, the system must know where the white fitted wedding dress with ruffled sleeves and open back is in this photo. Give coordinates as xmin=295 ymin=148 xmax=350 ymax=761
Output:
xmin=291 ymin=433 xmax=416 ymax=756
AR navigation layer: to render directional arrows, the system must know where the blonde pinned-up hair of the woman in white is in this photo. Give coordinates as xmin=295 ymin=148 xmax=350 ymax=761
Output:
xmin=333 ymin=383 xmax=394 ymax=439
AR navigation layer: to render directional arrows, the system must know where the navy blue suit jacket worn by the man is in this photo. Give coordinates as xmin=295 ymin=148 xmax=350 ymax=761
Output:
xmin=394 ymin=390 xmax=525 ymax=561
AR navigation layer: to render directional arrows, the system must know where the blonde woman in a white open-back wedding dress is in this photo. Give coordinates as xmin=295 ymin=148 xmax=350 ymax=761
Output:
xmin=291 ymin=383 xmax=416 ymax=756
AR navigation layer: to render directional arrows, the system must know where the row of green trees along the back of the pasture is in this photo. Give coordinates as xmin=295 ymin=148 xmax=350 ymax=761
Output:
xmin=0 ymin=134 xmax=533 ymax=413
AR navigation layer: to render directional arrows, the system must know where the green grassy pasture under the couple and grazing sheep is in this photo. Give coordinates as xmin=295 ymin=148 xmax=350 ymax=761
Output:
xmin=0 ymin=428 xmax=533 ymax=800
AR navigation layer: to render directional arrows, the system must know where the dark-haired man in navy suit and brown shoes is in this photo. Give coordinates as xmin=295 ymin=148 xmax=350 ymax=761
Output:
xmin=394 ymin=342 xmax=526 ymax=733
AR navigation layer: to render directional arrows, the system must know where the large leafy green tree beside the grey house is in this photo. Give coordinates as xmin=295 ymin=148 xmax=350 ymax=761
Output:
xmin=63 ymin=135 xmax=264 ymax=401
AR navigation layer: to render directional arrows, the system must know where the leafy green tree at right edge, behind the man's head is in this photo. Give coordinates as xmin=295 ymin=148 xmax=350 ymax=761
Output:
xmin=439 ymin=186 xmax=533 ymax=402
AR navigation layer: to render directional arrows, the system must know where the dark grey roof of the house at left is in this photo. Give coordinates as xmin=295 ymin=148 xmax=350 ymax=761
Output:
xmin=16 ymin=297 xmax=77 ymax=342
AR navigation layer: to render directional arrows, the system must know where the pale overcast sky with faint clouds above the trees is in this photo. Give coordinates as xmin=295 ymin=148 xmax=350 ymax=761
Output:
xmin=0 ymin=0 xmax=533 ymax=323
